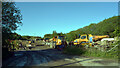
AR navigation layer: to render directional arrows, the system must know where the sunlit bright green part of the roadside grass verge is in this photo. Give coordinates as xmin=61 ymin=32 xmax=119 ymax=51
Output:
xmin=84 ymin=47 xmax=118 ymax=59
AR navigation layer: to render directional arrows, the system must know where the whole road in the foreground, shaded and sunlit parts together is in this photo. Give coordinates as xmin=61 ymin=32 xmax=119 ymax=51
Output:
xmin=2 ymin=46 xmax=118 ymax=67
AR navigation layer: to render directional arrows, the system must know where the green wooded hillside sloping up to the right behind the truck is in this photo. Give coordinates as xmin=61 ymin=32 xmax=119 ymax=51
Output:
xmin=65 ymin=16 xmax=120 ymax=41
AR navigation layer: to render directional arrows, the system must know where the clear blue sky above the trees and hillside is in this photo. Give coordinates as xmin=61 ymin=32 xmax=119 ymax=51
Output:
xmin=16 ymin=2 xmax=118 ymax=37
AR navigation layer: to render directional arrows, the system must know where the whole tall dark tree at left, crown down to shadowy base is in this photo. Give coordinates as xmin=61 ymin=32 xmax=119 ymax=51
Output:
xmin=2 ymin=2 xmax=22 ymax=59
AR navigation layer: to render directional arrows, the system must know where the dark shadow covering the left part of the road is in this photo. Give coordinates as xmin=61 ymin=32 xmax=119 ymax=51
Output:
xmin=2 ymin=49 xmax=79 ymax=67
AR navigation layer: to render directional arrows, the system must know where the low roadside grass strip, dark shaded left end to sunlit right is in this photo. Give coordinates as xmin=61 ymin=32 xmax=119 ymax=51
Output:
xmin=63 ymin=43 xmax=118 ymax=59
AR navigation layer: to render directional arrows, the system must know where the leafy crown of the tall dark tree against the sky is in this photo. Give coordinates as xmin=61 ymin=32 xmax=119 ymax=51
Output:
xmin=2 ymin=2 xmax=22 ymax=33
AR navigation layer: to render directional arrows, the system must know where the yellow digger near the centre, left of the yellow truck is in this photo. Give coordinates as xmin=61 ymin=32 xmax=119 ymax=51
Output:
xmin=52 ymin=36 xmax=67 ymax=49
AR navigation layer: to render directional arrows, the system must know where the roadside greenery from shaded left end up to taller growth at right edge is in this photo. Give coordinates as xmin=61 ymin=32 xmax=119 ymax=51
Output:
xmin=63 ymin=39 xmax=120 ymax=59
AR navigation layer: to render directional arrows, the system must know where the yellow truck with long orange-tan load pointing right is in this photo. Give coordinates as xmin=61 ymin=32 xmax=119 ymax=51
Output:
xmin=74 ymin=34 xmax=109 ymax=46
